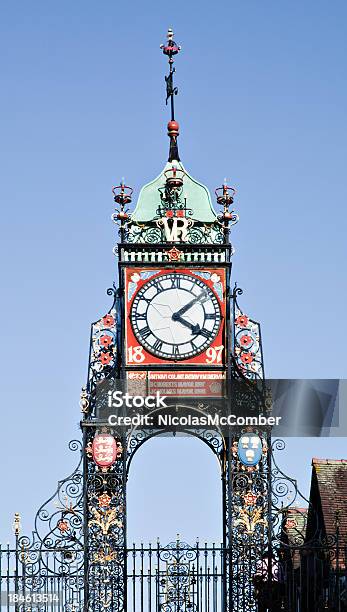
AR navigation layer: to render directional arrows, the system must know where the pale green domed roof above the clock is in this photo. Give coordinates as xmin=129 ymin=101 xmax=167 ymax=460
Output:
xmin=131 ymin=162 xmax=217 ymax=223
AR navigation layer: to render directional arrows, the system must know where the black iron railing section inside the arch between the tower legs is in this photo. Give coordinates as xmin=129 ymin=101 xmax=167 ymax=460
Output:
xmin=127 ymin=541 xmax=225 ymax=612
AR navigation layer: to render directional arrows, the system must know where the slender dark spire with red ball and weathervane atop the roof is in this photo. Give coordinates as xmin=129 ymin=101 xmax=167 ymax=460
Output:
xmin=160 ymin=28 xmax=181 ymax=162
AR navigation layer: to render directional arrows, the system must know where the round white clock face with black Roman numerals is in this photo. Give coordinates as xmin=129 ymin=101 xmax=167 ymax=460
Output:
xmin=130 ymin=272 xmax=221 ymax=361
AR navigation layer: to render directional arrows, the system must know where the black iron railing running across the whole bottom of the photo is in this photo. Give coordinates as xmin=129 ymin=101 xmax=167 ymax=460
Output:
xmin=0 ymin=540 xmax=347 ymax=612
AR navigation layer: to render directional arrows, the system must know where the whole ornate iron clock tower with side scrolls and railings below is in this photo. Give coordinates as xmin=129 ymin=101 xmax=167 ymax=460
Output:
xmin=4 ymin=30 xmax=346 ymax=612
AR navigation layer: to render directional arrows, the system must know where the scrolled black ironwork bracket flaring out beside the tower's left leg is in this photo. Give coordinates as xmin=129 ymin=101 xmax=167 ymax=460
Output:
xmin=0 ymin=440 xmax=84 ymax=610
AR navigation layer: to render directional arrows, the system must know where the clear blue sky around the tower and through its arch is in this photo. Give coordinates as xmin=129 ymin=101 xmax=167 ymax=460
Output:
xmin=0 ymin=0 xmax=347 ymax=542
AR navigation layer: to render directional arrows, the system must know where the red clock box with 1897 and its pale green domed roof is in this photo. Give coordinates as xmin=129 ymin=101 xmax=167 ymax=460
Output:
xmin=121 ymin=131 xmax=232 ymax=371
